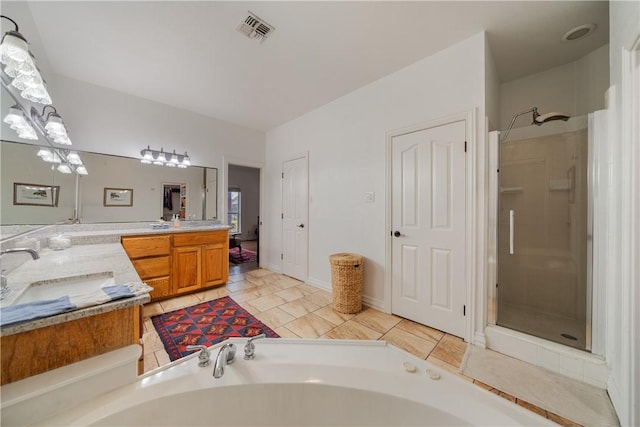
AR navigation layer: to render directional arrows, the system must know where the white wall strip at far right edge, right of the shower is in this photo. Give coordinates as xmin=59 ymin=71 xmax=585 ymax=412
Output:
xmin=601 ymin=1 xmax=640 ymax=425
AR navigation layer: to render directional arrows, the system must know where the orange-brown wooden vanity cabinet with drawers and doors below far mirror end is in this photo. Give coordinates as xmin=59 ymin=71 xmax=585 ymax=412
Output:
xmin=122 ymin=230 xmax=229 ymax=300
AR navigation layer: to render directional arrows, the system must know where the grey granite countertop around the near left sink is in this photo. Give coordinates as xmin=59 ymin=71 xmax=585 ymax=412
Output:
xmin=0 ymin=243 xmax=151 ymax=336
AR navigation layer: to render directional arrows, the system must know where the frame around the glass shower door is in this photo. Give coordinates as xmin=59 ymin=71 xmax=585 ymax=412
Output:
xmin=485 ymin=114 xmax=606 ymax=356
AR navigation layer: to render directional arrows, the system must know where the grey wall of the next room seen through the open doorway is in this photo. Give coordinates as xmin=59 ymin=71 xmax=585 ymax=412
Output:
xmin=228 ymin=165 xmax=260 ymax=240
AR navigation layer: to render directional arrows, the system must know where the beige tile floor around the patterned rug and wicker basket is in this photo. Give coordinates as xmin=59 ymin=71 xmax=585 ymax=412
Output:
xmin=142 ymin=270 xmax=579 ymax=426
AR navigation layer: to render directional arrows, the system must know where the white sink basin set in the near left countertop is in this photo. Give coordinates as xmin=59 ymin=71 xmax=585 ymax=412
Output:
xmin=11 ymin=271 xmax=115 ymax=305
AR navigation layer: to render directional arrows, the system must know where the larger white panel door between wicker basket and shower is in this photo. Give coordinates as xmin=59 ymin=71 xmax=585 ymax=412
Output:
xmin=391 ymin=121 xmax=466 ymax=337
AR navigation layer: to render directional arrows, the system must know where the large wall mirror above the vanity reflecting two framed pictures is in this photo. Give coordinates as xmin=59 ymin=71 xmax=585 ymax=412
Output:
xmin=0 ymin=141 xmax=218 ymax=226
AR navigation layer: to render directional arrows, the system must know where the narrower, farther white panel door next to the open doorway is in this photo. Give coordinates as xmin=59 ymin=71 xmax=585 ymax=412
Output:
xmin=282 ymin=158 xmax=309 ymax=281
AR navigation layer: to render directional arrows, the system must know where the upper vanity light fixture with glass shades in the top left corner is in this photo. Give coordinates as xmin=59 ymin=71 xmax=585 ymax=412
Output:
xmin=0 ymin=15 xmax=51 ymax=105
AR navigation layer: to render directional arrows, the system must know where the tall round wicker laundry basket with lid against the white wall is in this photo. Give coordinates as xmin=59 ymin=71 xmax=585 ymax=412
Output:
xmin=329 ymin=253 xmax=364 ymax=313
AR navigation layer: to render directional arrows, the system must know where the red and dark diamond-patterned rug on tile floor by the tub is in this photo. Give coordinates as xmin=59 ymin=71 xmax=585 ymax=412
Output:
xmin=151 ymin=297 xmax=280 ymax=361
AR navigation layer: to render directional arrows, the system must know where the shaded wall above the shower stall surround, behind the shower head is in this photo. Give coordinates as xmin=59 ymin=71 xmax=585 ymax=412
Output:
xmin=499 ymin=45 xmax=609 ymax=129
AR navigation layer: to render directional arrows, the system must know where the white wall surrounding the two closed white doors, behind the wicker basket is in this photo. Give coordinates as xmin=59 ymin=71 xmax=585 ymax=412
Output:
xmin=265 ymin=33 xmax=485 ymax=307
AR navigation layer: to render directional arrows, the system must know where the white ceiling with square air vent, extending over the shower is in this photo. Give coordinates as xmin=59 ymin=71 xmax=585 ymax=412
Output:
xmin=16 ymin=1 xmax=609 ymax=130
